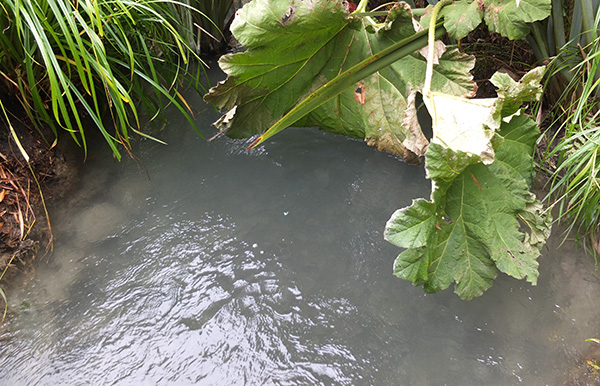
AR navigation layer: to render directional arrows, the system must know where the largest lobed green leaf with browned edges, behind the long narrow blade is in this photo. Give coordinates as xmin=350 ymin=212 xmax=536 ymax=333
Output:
xmin=205 ymin=0 xmax=475 ymax=157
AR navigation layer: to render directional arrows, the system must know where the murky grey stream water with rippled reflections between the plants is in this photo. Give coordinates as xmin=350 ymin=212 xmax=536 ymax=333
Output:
xmin=0 ymin=68 xmax=600 ymax=385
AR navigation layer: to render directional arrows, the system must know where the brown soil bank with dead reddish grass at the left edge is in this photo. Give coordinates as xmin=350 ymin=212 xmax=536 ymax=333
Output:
xmin=0 ymin=119 xmax=75 ymax=302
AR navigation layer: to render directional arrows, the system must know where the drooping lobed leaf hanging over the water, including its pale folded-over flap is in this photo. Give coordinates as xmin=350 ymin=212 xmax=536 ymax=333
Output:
xmin=385 ymin=64 xmax=550 ymax=299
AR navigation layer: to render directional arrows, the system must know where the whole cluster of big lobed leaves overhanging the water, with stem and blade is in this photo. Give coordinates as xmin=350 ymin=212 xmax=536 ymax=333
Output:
xmin=205 ymin=0 xmax=550 ymax=299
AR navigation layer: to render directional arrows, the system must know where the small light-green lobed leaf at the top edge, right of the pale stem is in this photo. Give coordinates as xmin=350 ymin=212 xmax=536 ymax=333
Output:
xmin=438 ymin=0 xmax=551 ymax=40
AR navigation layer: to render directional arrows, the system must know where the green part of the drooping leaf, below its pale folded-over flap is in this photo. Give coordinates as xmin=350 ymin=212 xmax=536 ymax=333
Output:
xmin=385 ymin=115 xmax=550 ymax=299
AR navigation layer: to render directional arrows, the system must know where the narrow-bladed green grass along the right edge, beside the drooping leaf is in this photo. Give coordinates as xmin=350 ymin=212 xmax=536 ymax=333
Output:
xmin=546 ymin=6 xmax=600 ymax=252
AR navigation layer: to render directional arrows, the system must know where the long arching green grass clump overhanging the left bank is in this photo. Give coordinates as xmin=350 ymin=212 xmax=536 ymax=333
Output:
xmin=0 ymin=0 xmax=209 ymax=159
